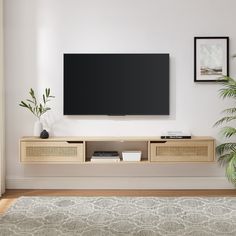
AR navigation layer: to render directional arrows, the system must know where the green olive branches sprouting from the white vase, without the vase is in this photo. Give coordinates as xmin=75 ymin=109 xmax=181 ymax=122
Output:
xmin=19 ymin=88 xmax=55 ymax=120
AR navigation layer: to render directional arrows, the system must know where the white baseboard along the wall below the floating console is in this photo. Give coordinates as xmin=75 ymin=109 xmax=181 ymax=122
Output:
xmin=6 ymin=177 xmax=234 ymax=189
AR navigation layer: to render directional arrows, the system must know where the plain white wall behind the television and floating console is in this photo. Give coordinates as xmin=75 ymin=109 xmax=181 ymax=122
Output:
xmin=4 ymin=0 xmax=236 ymax=188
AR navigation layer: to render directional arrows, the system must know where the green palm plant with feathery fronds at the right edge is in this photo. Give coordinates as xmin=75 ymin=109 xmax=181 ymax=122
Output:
xmin=214 ymin=76 xmax=236 ymax=186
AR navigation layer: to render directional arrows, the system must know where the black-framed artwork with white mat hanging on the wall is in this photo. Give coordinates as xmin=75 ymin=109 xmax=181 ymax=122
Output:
xmin=194 ymin=37 xmax=229 ymax=82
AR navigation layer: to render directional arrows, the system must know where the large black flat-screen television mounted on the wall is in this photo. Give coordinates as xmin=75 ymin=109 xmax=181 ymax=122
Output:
xmin=64 ymin=53 xmax=169 ymax=115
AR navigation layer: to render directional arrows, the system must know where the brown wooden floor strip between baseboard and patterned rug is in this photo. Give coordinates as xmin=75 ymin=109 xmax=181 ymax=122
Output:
xmin=0 ymin=189 xmax=236 ymax=214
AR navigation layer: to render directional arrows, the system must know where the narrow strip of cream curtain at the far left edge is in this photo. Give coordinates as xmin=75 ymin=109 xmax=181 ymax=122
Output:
xmin=0 ymin=0 xmax=5 ymax=195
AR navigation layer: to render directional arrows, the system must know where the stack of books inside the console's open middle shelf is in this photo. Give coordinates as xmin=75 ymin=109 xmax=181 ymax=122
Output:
xmin=91 ymin=151 xmax=120 ymax=162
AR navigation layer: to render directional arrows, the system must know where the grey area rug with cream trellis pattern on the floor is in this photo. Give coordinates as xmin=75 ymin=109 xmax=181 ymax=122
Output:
xmin=0 ymin=197 xmax=236 ymax=236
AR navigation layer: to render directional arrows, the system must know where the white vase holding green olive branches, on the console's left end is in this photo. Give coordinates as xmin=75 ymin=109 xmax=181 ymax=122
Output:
xmin=19 ymin=88 xmax=54 ymax=137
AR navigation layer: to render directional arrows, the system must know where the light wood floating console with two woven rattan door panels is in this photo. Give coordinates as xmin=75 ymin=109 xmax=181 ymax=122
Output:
xmin=20 ymin=137 xmax=215 ymax=164
